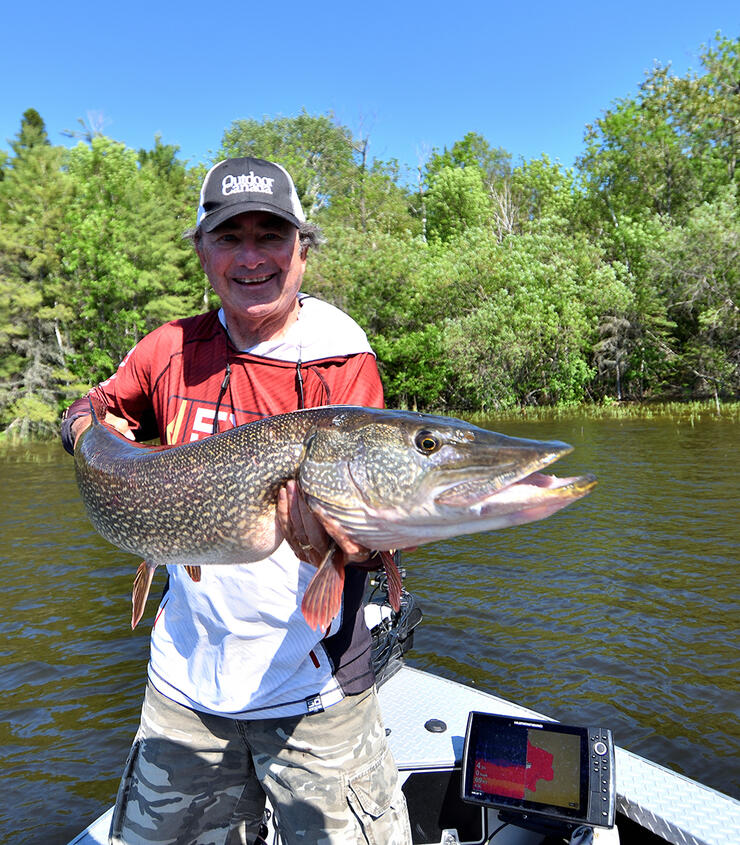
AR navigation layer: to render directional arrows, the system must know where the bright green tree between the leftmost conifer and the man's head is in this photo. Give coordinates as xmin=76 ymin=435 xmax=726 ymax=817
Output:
xmin=61 ymin=137 xmax=202 ymax=383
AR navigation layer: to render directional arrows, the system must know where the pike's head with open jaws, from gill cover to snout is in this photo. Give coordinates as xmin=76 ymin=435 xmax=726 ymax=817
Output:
xmin=300 ymin=411 xmax=596 ymax=550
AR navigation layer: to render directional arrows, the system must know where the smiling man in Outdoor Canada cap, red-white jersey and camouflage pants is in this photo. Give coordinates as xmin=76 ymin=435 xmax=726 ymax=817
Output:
xmin=62 ymin=158 xmax=411 ymax=845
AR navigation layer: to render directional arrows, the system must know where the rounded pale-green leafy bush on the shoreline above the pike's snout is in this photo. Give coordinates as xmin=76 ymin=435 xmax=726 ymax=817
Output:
xmin=445 ymin=231 xmax=629 ymax=409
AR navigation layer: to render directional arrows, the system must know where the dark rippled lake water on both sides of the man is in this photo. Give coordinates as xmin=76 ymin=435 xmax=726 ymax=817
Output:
xmin=0 ymin=408 xmax=740 ymax=845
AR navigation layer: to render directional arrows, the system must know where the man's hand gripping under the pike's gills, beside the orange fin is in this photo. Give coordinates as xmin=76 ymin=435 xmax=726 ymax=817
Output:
xmin=277 ymin=480 xmax=371 ymax=566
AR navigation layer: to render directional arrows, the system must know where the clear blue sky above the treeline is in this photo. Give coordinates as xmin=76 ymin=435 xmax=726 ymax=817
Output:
xmin=0 ymin=0 xmax=740 ymax=175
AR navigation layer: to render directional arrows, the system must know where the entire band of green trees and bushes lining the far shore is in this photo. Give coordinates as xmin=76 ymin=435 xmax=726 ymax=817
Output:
xmin=0 ymin=33 xmax=740 ymax=442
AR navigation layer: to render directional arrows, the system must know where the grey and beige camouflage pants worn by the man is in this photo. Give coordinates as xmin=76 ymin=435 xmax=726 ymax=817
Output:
xmin=109 ymin=685 xmax=411 ymax=845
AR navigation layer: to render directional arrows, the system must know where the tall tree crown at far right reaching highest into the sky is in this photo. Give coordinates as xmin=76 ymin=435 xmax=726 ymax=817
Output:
xmin=579 ymin=35 xmax=740 ymax=223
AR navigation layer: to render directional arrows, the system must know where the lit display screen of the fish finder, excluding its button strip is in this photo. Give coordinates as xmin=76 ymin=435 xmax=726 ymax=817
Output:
xmin=463 ymin=714 xmax=588 ymax=818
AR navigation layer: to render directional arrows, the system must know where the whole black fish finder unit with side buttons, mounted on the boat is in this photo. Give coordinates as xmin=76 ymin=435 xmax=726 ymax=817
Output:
xmin=461 ymin=712 xmax=615 ymax=832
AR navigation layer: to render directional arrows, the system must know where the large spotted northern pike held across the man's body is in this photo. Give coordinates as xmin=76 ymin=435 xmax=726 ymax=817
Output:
xmin=75 ymin=405 xmax=596 ymax=629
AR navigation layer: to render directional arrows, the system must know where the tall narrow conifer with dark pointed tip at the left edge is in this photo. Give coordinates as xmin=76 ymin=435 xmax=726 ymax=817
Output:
xmin=0 ymin=109 xmax=73 ymax=436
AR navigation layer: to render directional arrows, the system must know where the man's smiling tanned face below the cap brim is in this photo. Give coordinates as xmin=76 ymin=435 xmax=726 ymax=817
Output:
xmin=196 ymin=211 xmax=306 ymax=345
